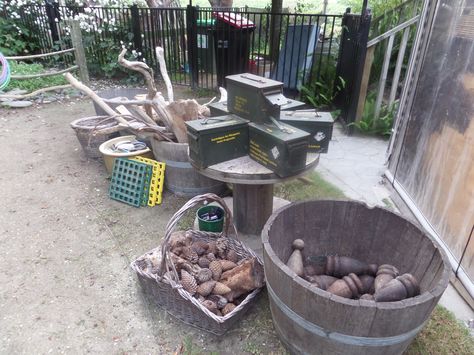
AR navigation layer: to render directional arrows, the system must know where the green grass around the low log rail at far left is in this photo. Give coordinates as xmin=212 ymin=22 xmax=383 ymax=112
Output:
xmin=7 ymin=61 xmax=67 ymax=92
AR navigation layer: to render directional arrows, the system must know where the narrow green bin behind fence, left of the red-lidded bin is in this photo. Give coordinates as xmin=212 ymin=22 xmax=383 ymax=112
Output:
xmin=196 ymin=18 xmax=216 ymax=73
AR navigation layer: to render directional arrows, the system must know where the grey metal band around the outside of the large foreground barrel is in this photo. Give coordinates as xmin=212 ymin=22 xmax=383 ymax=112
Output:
xmin=266 ymin=283 xmax=426 ymax=346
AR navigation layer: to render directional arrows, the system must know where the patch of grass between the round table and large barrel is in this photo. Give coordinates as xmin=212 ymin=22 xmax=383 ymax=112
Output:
xmin=275 ymin=171 xmax=345 ymax=202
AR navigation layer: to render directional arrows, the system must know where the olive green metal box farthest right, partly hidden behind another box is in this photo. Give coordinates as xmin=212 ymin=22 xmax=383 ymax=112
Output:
xmin=280 ymin=110 xmax=334 ymax=153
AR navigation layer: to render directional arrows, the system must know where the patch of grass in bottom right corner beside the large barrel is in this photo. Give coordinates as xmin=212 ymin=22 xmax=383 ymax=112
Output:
xmin=405 ymin=306 xmax=474 ymax=355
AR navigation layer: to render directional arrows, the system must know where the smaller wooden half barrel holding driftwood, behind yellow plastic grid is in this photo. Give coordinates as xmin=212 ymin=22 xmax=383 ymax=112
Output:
xmin=151 ymin=139 xmax=227 ymax=197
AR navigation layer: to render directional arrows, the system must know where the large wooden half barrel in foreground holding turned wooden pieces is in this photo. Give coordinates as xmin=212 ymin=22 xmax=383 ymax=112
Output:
xmin=262 ymin=201 xmax=450 ymax=355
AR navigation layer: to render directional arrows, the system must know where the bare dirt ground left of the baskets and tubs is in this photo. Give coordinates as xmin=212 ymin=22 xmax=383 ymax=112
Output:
xmin=0 ymin=99 xmax=284 ymax=354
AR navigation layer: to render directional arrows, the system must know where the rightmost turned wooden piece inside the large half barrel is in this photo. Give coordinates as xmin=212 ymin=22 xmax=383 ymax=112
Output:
xmin=374 ymin=274 xmax=420 ymax=302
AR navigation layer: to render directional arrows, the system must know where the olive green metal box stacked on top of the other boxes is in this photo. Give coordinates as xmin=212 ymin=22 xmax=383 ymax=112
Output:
xmin=226 ymin=73 xmax=287 ymax=123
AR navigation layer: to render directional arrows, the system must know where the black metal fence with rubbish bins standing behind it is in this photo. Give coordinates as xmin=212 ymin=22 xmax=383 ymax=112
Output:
xmin=12 ymin=4 xmax=342 ymax=94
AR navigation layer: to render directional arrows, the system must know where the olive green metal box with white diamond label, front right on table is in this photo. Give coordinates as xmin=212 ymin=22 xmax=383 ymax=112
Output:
xmin=249 ymin=122 xmax=309 ymax=177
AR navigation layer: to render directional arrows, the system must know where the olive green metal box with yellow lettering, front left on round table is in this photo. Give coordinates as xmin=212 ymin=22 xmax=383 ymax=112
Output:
xmin=186 ymin=115 xmax=249 ymax=169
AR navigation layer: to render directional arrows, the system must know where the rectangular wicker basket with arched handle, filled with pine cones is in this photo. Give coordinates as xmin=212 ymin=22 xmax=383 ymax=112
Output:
xmin=131 ymin=194 xmax=263 ymax=335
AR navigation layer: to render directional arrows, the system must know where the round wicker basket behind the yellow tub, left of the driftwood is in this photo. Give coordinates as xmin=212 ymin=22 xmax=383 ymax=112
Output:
xmin=71 ymin=116 xmax=123 ymax=159
